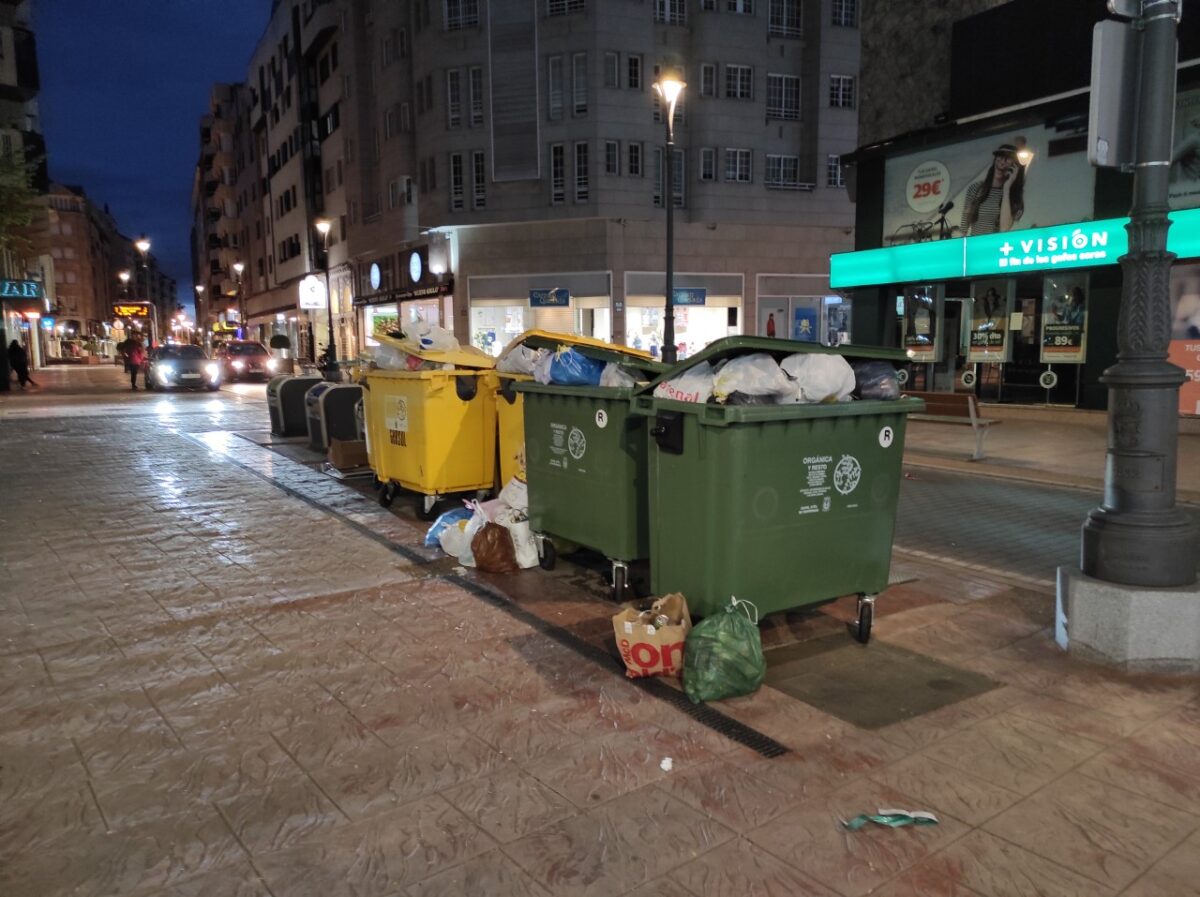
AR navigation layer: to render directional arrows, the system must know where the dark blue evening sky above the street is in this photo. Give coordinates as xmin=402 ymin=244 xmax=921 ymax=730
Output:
xmin=34 ymin=0 xmax=270 ymax=307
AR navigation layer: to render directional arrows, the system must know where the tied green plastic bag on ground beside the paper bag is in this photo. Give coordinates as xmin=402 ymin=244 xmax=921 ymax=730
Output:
xmin=683 ymin=598 xmax=767 ymax=704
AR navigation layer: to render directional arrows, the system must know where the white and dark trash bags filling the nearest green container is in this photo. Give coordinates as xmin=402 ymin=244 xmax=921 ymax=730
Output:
xmin=654 ymin=353 xmax=900 ymax=405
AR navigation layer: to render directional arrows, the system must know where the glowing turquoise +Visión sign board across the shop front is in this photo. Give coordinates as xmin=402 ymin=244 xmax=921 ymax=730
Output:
xmin=829 ymin=209 xmax=1200 ymax=289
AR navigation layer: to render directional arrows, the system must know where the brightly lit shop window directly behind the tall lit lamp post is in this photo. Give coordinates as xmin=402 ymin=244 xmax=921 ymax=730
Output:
xmin=625 ymin=271 xmax=744 ymax=359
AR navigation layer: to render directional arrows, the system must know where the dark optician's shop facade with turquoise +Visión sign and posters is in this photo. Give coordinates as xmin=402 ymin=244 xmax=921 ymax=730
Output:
xmin=830 ymin=0 xmax=1200 ymax=416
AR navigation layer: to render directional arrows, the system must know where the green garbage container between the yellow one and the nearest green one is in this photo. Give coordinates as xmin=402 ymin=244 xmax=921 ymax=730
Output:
xmin=512 ymin=344 xmax=666 ymax=597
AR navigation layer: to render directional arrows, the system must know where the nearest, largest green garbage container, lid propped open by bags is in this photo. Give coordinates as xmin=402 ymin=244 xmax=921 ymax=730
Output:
xmin=634 ymin=337 xmax=924 ymax=642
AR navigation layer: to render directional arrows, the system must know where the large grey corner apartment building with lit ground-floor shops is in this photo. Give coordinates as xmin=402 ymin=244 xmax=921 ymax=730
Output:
xmin=194 ymin=0 xmax=859 ymax=356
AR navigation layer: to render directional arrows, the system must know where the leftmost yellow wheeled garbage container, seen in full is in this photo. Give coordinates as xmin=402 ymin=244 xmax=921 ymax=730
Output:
xmin=360 ymin=337 xmax=497 ymax=519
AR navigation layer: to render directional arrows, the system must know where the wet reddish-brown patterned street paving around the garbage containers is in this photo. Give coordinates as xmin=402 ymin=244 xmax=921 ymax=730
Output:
xmin=0 ymin=371 xmax=1200 ymax=897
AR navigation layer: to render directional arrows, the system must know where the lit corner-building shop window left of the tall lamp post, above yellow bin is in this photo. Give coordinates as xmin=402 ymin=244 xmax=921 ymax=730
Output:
xmin=468 ymin=271 xmax=612 ymax=355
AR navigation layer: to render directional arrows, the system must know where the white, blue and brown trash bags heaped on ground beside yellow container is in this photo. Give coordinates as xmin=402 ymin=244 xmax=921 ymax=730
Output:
xmin=425 ymin=477 xmax=539 ymax=573
